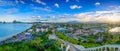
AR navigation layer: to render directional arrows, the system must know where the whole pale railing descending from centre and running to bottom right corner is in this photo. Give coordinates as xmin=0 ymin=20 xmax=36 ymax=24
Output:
xmin=60 ymin=34 xmax=120 ymax=51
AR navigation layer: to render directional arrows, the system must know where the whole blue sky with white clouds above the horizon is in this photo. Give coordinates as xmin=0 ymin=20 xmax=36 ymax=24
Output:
xmin=0 ymin=0 xmax=120 ymax=22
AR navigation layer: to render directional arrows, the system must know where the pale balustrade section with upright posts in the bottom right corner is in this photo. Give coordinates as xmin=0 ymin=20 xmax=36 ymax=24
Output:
xmin=81 ymin=45 xmax=120 ymax=51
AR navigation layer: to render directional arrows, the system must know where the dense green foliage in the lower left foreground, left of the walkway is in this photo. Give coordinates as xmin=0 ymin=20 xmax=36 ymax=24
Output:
xmin=0 ymin=33 xmax=61 ymax=51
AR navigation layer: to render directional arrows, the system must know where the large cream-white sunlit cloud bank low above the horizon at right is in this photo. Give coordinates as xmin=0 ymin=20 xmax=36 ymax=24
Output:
xmin=74 ymin=10 xmax=120 ymax=23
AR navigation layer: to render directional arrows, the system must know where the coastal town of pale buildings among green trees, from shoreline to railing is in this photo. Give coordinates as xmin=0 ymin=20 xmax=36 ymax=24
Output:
xmin=0 ymin=23 xmax=120 ymax=51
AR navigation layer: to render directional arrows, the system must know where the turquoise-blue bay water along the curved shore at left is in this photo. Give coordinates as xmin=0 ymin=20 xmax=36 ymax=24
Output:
xmin=0 ymin=23 xmax=32 ymax=41
